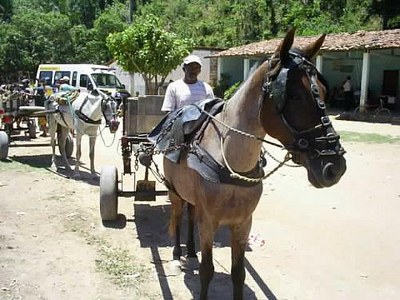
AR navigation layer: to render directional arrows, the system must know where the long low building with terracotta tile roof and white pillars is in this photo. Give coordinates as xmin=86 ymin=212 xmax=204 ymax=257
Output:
xmin=210 ymin=29 xmax=400 ymax=110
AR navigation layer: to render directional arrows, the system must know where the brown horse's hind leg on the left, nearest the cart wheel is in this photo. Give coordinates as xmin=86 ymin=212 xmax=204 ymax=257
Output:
xmin=168 ymin=192 xmax=184 ymax=261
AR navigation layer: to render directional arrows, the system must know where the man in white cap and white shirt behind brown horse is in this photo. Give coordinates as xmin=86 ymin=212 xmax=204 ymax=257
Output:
xmin=161 ymin=55 xmax=215 ymax=112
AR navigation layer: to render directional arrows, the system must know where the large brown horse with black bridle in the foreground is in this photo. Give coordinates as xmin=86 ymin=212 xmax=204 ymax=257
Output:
xmin=164 ymin=30 xmax=346 ymax=299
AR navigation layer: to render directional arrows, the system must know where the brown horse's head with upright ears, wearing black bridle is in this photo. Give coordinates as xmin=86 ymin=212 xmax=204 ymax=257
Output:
xmin=260 ymin=29 xmax=346 ymax=188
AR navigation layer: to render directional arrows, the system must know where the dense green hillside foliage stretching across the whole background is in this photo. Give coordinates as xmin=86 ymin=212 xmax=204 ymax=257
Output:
xmin=0 ymin=0 xmax=400 ymax=81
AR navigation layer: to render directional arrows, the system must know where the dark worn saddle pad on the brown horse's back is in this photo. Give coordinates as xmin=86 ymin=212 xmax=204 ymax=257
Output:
xmin=147 ymin=98 xmax=225 ymax=163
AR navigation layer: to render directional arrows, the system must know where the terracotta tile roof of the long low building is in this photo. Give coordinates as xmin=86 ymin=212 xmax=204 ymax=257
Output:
xmin=211 ymin=29 xmax=400 ymax=57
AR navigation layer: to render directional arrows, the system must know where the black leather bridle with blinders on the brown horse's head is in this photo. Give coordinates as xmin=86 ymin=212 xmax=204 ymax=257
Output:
xmin=260 ymin=51 xmax=345 ymax=160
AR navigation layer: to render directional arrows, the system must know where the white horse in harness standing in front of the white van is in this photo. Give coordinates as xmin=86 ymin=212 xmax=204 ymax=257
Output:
xmin=46 ymin=90 xmax=119 ymax=177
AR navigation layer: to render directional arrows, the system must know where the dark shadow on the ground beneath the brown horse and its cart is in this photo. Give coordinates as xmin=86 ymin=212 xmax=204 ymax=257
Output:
xmin=122 ymin=202 xmax=276 ymax=299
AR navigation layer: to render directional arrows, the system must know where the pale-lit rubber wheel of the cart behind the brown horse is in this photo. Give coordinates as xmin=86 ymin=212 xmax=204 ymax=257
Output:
xmin=100 ymin=166 xmax=118 ymax=221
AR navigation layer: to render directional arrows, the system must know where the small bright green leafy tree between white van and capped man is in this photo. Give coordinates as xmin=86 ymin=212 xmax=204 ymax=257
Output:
xmin=107 ymin=15 xmax=193 ymax=94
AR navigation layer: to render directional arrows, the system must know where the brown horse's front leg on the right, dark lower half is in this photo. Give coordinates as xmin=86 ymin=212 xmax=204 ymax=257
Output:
xmin=231 ymin=216 xmax=252 ymax=300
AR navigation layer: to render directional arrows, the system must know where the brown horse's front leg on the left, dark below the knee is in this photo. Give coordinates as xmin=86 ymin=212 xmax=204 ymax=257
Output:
xmin=198 ymin=216 xmax=215 ymax=300
